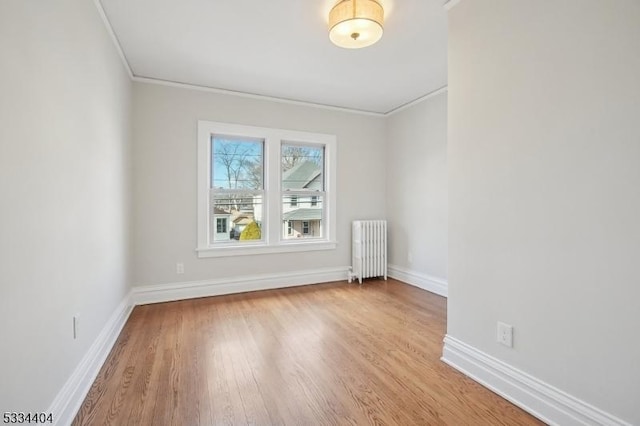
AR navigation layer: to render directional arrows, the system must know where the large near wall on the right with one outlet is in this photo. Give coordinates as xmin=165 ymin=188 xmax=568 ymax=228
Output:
xmin=448 ymin=0 xmax=640 ymax=424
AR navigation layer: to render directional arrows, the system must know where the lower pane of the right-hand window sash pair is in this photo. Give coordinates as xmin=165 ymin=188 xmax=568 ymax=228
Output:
xmin=282 ymin=195 xmax=323 ymax=240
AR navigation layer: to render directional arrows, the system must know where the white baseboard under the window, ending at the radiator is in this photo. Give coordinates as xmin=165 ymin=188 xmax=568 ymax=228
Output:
xmin=132 ymin=266 xmax=348 ymax=305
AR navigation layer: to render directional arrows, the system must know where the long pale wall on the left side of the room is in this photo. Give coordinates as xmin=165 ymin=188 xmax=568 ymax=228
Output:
xmin=0 ymin=0 xmax=131 ymax=412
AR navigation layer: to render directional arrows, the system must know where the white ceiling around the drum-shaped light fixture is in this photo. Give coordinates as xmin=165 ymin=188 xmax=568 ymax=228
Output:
xmin=100 ymin=0 xmax=447 ymax=113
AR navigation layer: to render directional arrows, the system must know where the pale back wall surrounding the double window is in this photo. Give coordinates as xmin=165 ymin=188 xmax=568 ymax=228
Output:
xmin=133 ymin=82 xmax=385 ymax=285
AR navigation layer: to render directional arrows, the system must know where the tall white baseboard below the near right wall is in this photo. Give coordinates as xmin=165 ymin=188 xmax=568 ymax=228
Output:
xmin=442 ymin=335 xmax=631 ymax=426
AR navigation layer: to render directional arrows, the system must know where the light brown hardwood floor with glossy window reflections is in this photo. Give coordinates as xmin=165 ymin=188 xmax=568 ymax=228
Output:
xmin=74 ymin=279 xmax=542 ymax=426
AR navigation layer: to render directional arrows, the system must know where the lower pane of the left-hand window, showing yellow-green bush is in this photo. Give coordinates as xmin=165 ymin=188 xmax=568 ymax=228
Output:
xmin=209 ymin=192 xmax=262 ymax=243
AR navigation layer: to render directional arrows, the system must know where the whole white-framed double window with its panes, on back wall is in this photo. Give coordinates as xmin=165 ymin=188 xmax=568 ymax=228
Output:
xmin=197 ymin=121 xmax=336 ymax=257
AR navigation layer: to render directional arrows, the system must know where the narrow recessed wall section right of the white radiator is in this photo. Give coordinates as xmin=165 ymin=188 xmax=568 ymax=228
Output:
xmin=386 ymin=92 xmax=447 ymax=290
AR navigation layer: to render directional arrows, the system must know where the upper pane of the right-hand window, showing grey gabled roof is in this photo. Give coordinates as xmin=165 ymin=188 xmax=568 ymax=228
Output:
xmin=280 ymin=144 xmax=324 ymax=191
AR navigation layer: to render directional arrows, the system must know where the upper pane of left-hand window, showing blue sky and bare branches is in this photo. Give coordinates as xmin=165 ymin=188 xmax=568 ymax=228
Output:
xmin=211 ymin=135 xmax=264 ymax=189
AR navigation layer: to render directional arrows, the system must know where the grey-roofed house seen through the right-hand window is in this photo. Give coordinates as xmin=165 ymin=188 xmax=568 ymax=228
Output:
xmin=282 ymin=161 xmax=323 ymax=238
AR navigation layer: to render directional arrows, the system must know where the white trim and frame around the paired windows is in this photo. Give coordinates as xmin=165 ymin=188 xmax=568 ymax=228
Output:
xmin=196 ymin=120 xmax=337 ymax=258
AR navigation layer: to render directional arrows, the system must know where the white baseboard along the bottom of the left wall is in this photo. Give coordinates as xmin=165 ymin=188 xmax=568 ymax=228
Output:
xmin=47 ymin=293 xmax=133 ymax=426
